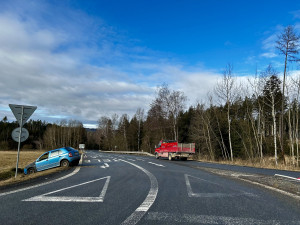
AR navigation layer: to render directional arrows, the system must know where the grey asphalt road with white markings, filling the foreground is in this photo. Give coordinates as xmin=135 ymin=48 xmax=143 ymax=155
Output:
xmin=0 ymin=151 xmax=300 ymax=225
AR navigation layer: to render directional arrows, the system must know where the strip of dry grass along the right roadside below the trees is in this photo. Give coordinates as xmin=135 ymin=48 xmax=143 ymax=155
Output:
xmin=197 ymin=156 xmax=300 ymax=171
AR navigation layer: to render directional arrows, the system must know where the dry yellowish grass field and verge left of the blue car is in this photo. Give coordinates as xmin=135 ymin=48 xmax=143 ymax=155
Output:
xmin=0 ymin=150 xmax=69 ymax=186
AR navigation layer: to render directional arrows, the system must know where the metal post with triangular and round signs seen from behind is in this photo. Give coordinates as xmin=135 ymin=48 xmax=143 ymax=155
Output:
xmin=9 ymin=104 xmax=37 ymax=178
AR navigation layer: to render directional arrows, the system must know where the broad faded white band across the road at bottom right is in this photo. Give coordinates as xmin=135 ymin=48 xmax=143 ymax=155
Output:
xmin=145 ymin=212 xmax=300 ymax=225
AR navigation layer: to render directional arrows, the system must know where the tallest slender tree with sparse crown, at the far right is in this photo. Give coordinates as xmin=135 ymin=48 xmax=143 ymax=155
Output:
xmin=276 ymin=25 xmax=300 ymax=163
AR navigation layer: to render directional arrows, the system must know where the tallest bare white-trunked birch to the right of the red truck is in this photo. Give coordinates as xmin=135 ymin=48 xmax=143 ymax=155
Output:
xmin=215 ymin=63 xmax=239 ymax=161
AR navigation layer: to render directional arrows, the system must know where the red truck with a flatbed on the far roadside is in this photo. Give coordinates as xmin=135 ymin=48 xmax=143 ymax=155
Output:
xmin=155 ymin=140 xmax=195 ymax=160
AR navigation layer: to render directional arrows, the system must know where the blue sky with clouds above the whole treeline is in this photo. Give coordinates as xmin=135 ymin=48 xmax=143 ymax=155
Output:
xmin=0 ymin=0 xmax=300 ymax=127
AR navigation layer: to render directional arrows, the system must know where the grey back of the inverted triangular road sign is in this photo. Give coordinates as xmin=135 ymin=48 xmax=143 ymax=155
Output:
xmin=9 ymin=104 xmax=37 ymax=127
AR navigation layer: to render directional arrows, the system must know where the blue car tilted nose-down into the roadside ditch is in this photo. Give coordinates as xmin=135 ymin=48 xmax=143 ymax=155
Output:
xmin=24 ymin=147 xmax=80 ymax=174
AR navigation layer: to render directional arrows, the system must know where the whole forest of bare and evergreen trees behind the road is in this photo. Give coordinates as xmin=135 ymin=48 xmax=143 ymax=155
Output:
xmin=0 ymin=26 xmax=300 ymax=167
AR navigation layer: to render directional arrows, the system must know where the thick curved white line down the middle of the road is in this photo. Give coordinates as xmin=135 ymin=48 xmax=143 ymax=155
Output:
xmin=121 ymin=159 xmax=158 ymax=225
